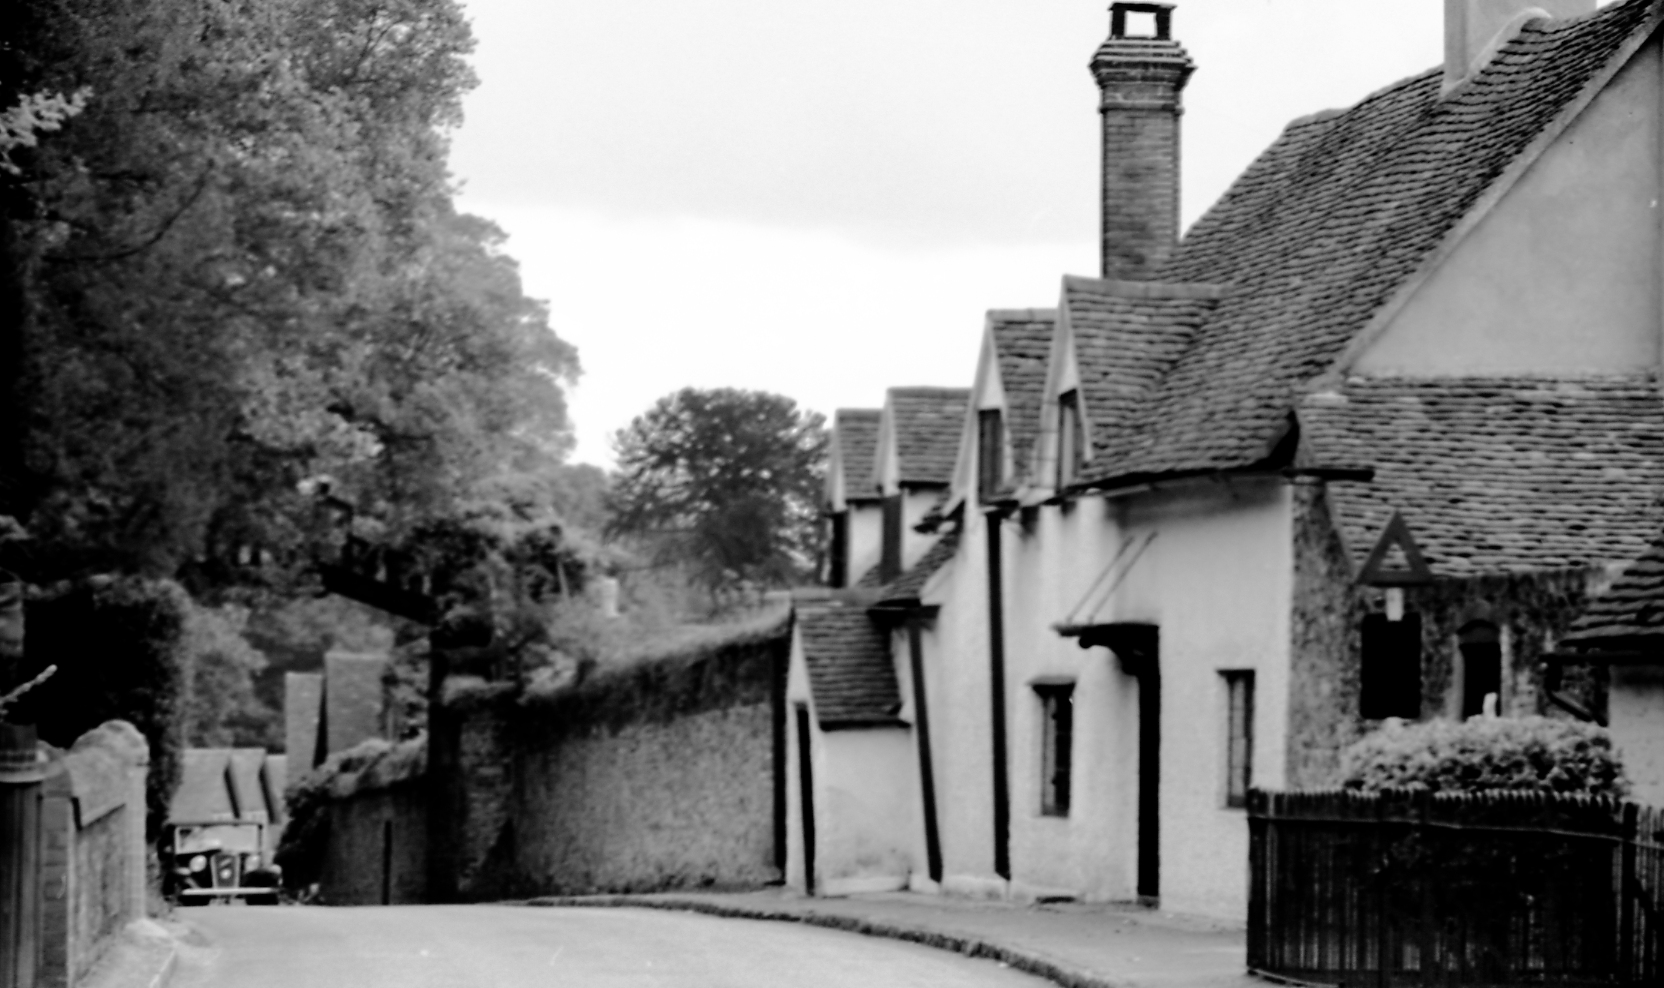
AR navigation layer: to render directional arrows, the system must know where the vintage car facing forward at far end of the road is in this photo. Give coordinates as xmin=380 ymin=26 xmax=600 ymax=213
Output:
xmin=161 ymin=820 xmax=281 ymax=905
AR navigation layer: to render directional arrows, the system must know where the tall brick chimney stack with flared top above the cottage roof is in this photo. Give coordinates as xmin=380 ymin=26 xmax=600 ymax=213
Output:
xmin=1092 ymin=3 xmax=1196 ymax=281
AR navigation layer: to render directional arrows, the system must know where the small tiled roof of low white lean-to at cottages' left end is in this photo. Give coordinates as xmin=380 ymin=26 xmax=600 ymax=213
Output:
xmin=797 ymin=605 xmax=902 ymax=730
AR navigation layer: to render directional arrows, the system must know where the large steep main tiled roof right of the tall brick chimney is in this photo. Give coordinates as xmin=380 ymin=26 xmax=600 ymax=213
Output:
xmin=1088 ymin=0 xmax=1657 ymax=482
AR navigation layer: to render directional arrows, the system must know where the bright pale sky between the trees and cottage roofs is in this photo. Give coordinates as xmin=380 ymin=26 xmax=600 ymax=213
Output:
xmin=451 ymin=0 xmax=1464 ymax=466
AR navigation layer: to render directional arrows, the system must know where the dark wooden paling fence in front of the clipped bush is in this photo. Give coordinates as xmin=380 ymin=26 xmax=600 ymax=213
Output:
xmin=1248 ymin=792 xmax=1664 ymax=988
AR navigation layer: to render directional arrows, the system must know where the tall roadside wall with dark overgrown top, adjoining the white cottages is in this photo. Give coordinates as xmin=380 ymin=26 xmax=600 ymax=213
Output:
xmin=434 ymin=620 xmax=790 ymax=900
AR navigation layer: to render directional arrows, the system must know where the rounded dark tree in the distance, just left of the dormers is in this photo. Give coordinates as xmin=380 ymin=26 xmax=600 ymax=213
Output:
xmin=607 ymin=388 xmax=827 ymax=590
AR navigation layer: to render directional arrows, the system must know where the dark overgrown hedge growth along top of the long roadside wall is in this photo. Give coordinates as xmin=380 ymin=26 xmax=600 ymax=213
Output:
xmin=459 ymin=612 xmax=792 ymax=732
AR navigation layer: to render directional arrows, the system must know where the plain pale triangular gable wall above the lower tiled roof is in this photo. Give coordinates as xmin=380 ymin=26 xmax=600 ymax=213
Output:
xmin=1353 ymin=42 xmax=1661 ymax=376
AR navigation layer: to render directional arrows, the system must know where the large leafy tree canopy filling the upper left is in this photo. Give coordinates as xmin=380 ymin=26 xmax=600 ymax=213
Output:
xmin=0 ymin=0 xmax=579 ymax=590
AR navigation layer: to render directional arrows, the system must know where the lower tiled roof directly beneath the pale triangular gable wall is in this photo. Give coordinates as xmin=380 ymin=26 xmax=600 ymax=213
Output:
xmin=1300 ymin=376 xmax=1664 ymax=576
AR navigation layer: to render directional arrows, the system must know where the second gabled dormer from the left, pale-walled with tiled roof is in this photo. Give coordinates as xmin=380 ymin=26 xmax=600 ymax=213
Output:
xmin=874 ymin=388 xmax=970 ymax=584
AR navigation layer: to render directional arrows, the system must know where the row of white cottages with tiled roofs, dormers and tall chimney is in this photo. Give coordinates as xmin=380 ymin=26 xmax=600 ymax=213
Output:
xmin=787 ymin=0 xmax=1664 ymax=918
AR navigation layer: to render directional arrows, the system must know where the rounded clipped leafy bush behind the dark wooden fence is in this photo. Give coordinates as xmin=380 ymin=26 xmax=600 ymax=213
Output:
xmin=1341 ymin=717 xmax=1629 ymax=797
